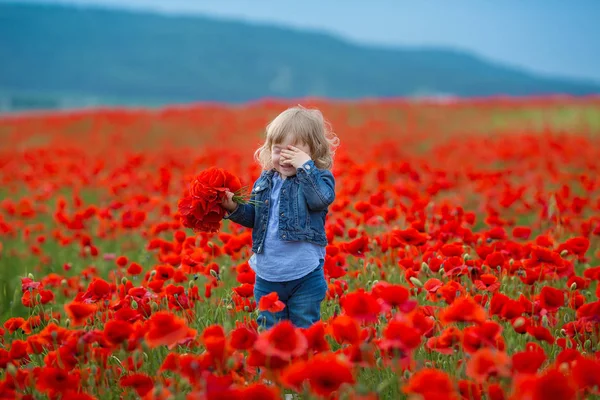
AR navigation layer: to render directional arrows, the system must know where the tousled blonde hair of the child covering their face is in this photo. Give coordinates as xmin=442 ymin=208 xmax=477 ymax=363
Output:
xmin=254 ymin=105 xmax=340 ymax=170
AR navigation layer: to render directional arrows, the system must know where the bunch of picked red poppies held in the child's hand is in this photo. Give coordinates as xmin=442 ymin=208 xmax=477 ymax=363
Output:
xmin=177 ymin=167 xmax=250 ymax=232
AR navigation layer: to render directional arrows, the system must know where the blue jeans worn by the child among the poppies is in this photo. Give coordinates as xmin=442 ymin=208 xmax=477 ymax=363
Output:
xmin=254 ymin=260 xmax=327 ymax=329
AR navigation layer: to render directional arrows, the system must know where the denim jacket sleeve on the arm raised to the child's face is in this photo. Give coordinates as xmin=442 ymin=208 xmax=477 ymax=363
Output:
xmin=296 ymin=160 xmax=335 ymax=211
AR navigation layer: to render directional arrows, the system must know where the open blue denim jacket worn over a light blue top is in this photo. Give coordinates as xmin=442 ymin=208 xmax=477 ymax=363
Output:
xmin=225 ymin=160 xmax=335 ymax=253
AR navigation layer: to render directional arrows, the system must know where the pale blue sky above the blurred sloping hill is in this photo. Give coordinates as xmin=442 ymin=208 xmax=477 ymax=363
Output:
xmin=13 ymin=0 xmax=600 ymax=82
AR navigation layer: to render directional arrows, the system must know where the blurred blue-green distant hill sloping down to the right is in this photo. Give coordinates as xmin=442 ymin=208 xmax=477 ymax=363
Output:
xmin=0 ymin=3 xmax=600 ymax=109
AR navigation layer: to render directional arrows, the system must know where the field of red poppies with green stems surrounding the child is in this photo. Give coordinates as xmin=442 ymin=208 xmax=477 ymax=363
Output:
xmin=0 ymin=98 xmax=600 ymax=400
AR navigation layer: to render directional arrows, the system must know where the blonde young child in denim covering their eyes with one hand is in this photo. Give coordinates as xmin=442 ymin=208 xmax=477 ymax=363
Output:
xmin=222 ymin=106 xmax=339 ymax=329
